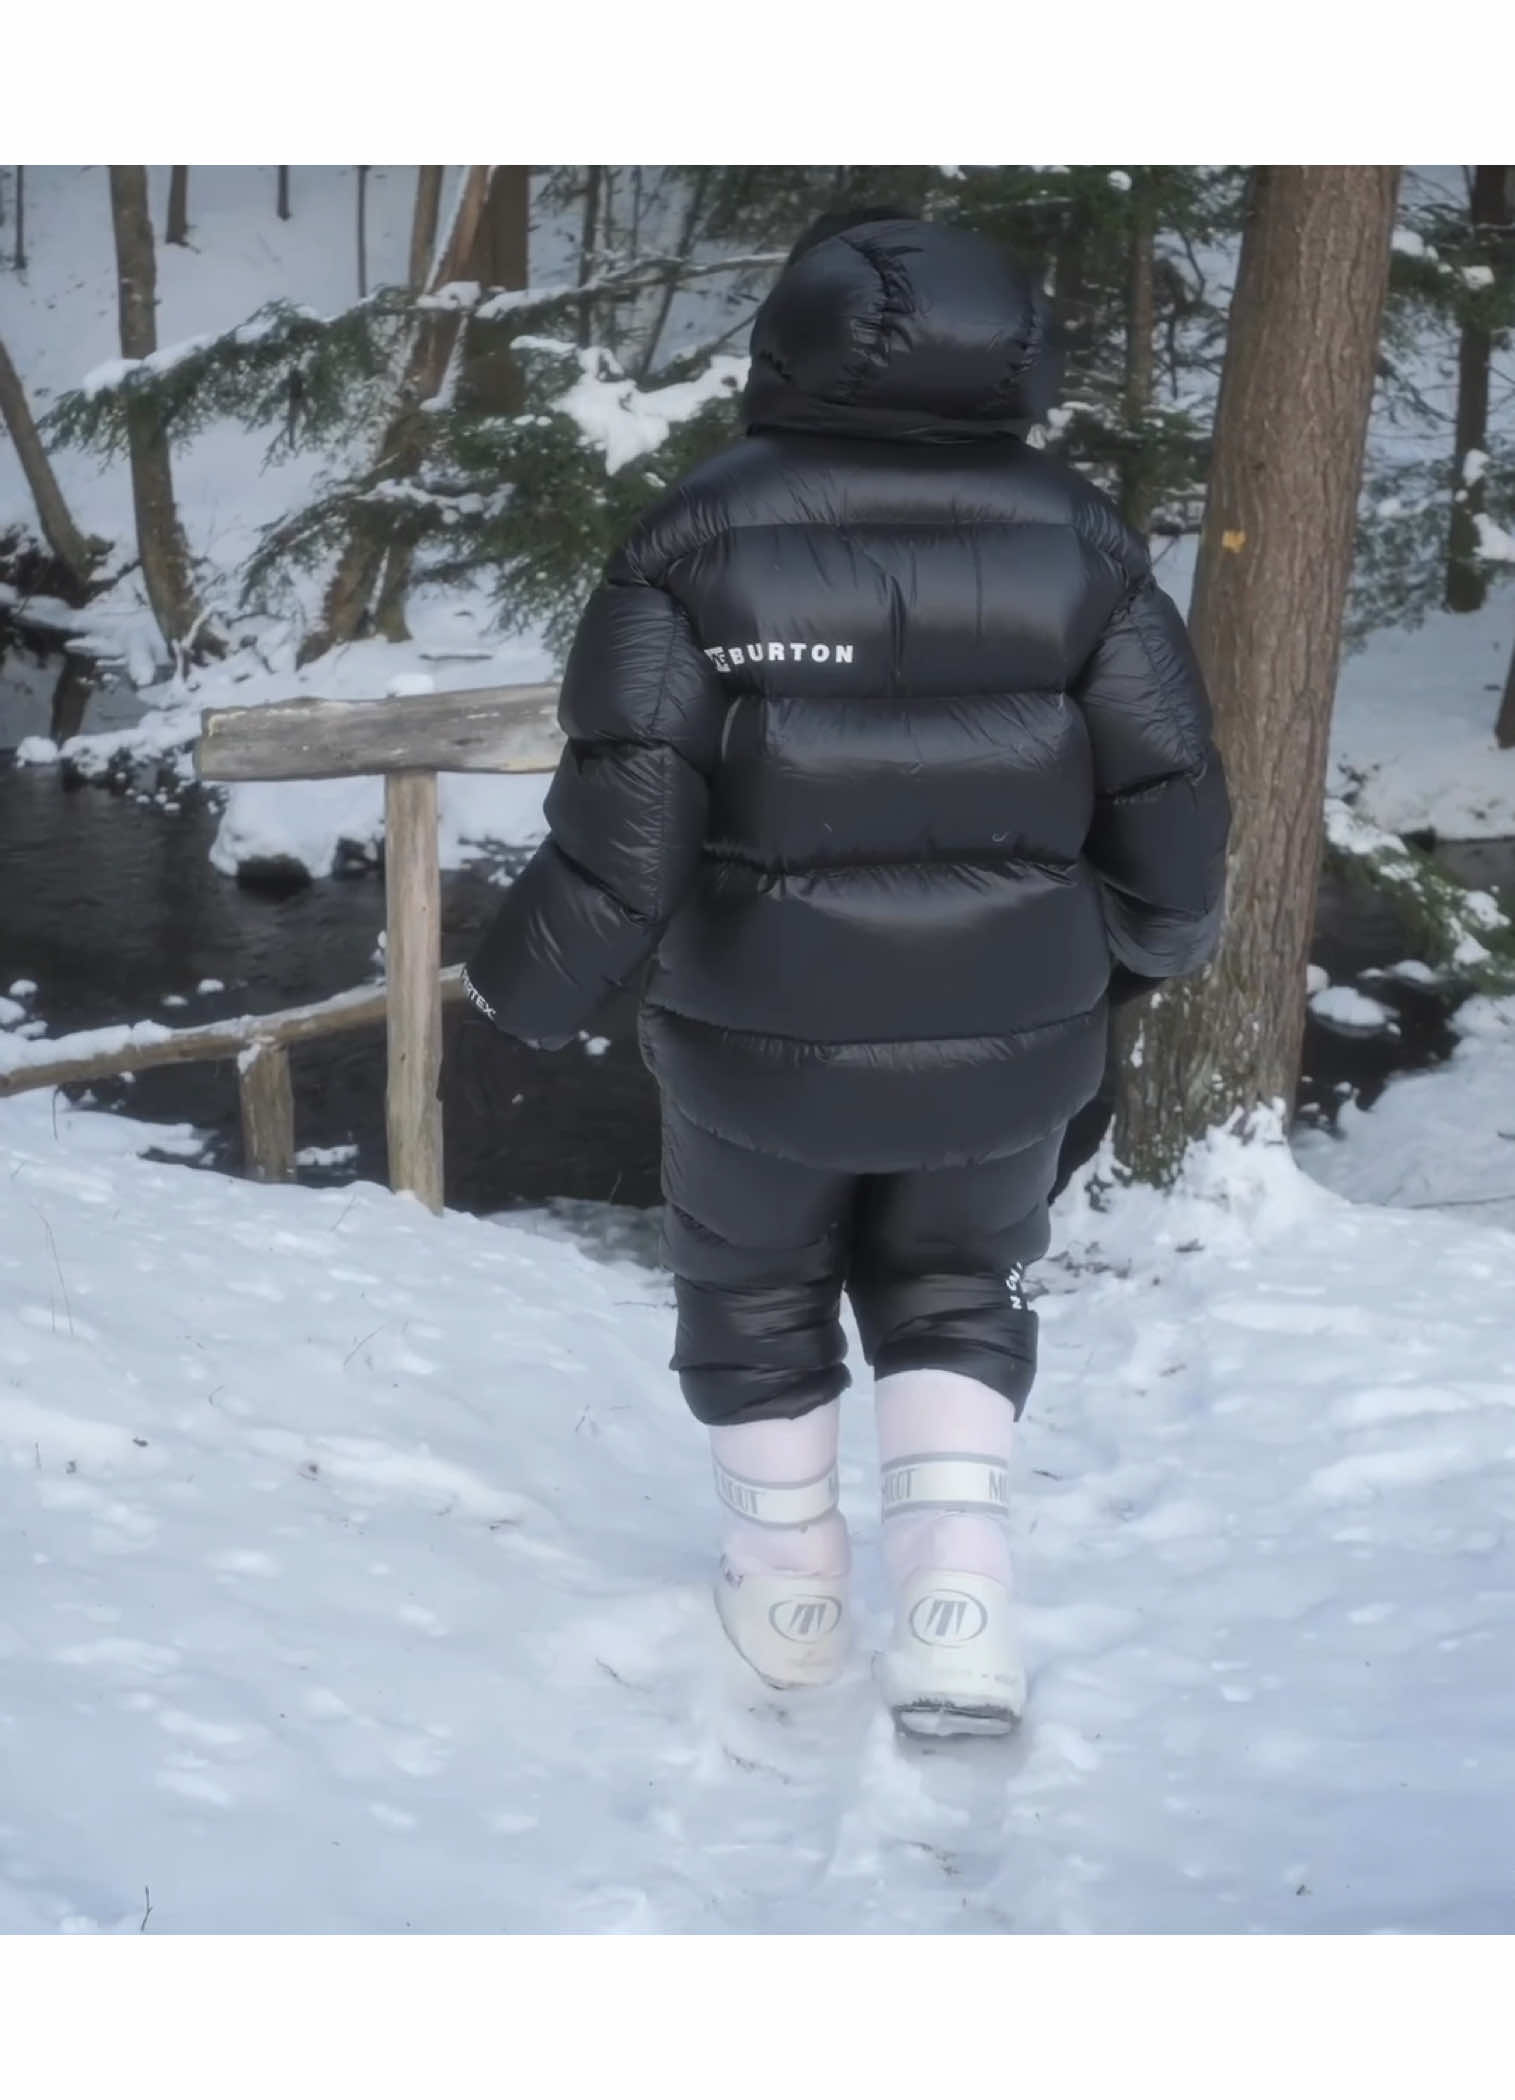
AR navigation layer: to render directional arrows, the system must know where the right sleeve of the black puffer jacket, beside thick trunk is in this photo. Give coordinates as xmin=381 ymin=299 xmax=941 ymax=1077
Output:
xmin=1074 ymin=569 xmax=1231 ymax=977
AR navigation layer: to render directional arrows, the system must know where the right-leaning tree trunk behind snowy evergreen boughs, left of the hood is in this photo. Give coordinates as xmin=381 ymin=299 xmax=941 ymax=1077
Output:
xmin=298 ymin=166 xmax=487 ymax=664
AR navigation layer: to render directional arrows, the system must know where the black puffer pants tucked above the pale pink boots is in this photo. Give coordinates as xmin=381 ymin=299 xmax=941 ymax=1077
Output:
xmin=662 ymin=1094 xmax=1061 ymax=1422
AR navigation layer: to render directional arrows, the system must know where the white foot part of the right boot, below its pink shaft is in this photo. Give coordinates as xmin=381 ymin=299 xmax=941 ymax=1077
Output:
xmin=876 ymin=1569 xmax=1025 ymax=1735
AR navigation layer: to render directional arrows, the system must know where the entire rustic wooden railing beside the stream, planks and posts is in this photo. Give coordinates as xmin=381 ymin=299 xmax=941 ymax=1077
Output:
xmin=0 ymin=685 xmax=563 ymax=1210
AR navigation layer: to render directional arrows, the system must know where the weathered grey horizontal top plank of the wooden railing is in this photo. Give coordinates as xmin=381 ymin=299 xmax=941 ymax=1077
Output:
xmin=195 ymin=685 xmax=563 ymax=781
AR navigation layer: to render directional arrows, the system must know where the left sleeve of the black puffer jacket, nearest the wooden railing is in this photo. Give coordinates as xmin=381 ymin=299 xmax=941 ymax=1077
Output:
xmin=464 ymin=563 xmax=725 ymax=1048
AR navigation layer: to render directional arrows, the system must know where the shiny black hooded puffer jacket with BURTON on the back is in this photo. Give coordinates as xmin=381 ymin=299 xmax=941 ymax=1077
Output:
xmin=469 ymin=221 xmax=1227 ymax=1172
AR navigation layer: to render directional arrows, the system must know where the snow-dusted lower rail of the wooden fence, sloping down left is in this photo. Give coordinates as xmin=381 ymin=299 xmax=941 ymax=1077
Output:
xmin=0 ymin=966 xmax=462 ymax=1098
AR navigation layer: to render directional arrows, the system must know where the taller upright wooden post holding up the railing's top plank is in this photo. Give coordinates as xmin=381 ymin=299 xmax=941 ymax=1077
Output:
xmin=385 ymin=773 xmax=441 ymax=1210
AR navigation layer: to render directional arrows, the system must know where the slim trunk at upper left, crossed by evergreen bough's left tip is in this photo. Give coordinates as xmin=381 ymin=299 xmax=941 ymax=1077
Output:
xmin=111 ymin=168 xmax=225 ymax=655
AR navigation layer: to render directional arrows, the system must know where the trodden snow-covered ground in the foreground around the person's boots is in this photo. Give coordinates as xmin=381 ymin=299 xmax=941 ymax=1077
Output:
xmin=0 ymin=1096 xmax=1515 ymax=1932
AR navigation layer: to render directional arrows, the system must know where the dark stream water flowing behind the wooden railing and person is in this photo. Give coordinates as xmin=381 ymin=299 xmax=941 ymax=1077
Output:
xmin=0 ymin=628 xmax=1515 ymax=1212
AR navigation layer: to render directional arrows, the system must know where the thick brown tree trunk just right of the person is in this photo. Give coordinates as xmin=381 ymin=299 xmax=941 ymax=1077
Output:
xmin=1116 ymin=166 xmax=1399 ymax=1182
